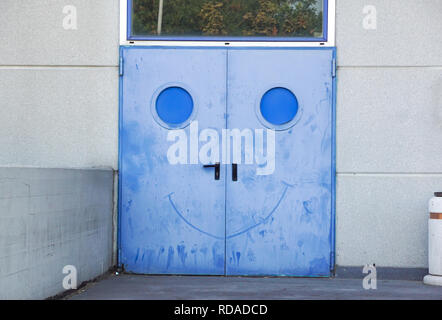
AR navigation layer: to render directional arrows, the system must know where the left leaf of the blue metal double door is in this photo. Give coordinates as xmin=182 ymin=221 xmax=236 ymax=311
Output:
xmin=119 ymin=47 xmax=226 ymax=275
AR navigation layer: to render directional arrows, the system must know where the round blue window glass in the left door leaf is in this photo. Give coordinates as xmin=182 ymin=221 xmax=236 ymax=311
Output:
xmin=155 ymin=87 xmax=193 ymax=125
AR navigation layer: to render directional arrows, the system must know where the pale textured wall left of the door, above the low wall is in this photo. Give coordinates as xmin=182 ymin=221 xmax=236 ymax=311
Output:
xmin=0 ymin=0 xmax=119 ymax=169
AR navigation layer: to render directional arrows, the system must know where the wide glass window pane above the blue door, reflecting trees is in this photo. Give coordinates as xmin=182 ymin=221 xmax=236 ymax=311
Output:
xmin=130 ymin=0 xmax=324 ymax=40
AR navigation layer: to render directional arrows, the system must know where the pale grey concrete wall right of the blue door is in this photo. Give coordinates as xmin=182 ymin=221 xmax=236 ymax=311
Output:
xmin=336 ymin=0 xmax=442 ymax=271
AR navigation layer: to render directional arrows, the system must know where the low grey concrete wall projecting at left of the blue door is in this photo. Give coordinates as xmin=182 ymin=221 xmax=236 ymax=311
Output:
xmin=0 ymin=168 xmax=113 ymax=299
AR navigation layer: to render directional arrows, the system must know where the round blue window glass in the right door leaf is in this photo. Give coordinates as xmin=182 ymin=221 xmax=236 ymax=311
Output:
xmin=260 ymin=88 xmax=298 ymax=126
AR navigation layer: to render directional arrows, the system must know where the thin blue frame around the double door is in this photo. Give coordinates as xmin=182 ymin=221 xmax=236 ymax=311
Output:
xmin=117 ymin=46 xmax=337 ymax=274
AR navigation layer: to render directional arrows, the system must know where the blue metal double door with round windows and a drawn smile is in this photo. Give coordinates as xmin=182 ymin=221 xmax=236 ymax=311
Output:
xmin=119 ymin=47 xmax=334 ymax=276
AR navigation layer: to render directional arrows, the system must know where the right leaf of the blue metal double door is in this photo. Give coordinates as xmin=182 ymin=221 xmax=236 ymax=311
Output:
xmin=226 ymin=49 xmax=334 ymax=276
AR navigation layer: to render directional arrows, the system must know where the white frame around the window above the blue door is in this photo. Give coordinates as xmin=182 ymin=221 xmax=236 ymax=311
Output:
xmin=120 ymin=0 xmax=336 ymax=47
